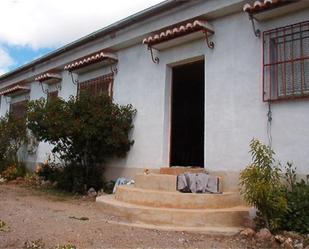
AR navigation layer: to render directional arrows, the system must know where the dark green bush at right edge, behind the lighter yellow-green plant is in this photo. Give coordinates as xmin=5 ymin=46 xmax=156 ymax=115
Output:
xmin=281 ymin=163 xmax=309 ymax=234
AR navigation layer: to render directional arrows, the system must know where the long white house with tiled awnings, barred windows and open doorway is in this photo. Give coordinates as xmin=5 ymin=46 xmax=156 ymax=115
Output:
xmin=0 ymin=0 xmax=309 ymax=191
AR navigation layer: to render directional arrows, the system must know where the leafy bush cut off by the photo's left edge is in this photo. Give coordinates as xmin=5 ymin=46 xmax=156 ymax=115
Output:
xmin=0 ymin=113 xmax=28 ymax=176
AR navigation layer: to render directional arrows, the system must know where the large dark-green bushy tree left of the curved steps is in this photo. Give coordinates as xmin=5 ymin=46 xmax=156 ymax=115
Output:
xmin=28 ymin=92 xmax=136 ymax=191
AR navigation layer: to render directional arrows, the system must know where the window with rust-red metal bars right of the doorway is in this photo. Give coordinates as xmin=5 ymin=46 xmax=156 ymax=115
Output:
xmin=263 ymin=21 xmax=309 ymax=101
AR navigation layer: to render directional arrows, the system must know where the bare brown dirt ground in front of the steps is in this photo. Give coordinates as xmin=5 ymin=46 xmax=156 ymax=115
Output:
xmin=0 ymin=184 xmax=278 ymax=249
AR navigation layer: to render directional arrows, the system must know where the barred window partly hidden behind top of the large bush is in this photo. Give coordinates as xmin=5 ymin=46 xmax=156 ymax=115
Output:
xmin=78 ymin=73 xmax=114 ymax=97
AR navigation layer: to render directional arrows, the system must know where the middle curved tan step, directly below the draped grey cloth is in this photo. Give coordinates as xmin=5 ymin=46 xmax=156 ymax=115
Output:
xmin=115 ymin=185 xmax=243 ymax=209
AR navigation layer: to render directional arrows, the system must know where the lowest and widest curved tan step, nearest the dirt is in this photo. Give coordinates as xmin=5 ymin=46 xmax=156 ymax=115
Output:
xmin=96 ymin=195 xmax=250 ymax=229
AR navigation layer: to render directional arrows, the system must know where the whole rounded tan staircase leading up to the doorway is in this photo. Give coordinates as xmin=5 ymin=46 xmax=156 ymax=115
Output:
xmin=96 ymin=168 xmax=250 ymax=234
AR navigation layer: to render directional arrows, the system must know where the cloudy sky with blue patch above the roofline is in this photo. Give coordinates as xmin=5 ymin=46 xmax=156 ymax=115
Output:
xmin=0 ymin=0 xmax=163 ymax=75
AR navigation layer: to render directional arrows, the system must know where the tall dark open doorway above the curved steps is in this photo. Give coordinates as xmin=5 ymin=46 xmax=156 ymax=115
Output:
xmin=170 ymin=61 xmax=205 ymax=167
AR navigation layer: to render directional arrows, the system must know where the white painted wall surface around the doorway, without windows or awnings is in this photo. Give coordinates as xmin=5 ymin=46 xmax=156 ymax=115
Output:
xmin=0 ymin=0 xmax=309 ymax=177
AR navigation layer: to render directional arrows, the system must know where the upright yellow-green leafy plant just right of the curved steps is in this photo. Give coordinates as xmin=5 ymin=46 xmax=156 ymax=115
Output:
xmin=240 ymin=139 xmax=287 ymax=231
